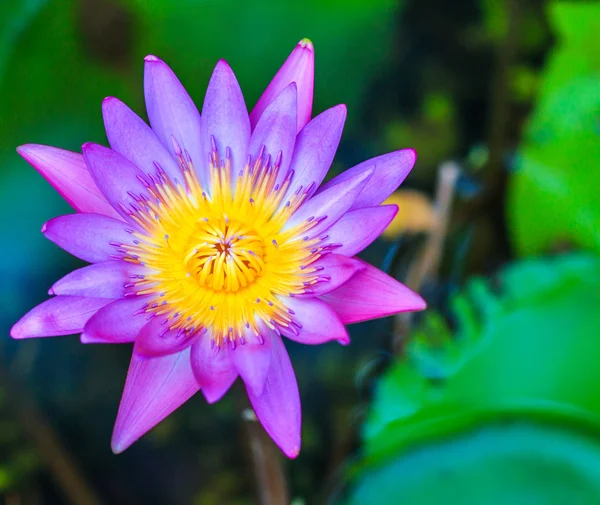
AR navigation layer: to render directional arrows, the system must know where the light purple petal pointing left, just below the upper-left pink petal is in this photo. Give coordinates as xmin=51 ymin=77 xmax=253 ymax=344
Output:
xmin=42 ymin=214 xmax=132 ymax=263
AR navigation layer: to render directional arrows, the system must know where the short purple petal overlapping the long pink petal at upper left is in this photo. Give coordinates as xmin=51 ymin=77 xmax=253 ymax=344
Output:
xmin=82 ymin=142 xmax=148 ymax=219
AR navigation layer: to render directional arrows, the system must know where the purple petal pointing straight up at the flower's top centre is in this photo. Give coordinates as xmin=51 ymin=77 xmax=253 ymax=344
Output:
xmin=202 ymin=60 xmax=250 ymax=175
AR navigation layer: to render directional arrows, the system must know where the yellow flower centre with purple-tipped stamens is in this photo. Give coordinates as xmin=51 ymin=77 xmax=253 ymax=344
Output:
xmin=123 ymin=148 xmax=331 ymax=345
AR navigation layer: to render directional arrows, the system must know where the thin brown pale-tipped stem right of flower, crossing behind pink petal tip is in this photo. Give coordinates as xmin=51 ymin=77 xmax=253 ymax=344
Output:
xmin=392 ymin=162 xmax=460 ymax=354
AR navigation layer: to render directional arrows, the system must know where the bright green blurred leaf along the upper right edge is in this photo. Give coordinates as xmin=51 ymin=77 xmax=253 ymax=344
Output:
xmin=507 ymin=2 xmax=600 ymax=255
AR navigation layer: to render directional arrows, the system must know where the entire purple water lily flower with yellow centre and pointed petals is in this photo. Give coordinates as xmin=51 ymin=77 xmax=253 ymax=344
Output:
xmin=11 ymin=40 xmax=425 ymax=457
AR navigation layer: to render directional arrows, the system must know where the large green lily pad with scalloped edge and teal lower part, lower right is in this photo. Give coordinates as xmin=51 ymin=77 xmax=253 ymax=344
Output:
xmin=348 ymin=254 xmax=600 ymax=504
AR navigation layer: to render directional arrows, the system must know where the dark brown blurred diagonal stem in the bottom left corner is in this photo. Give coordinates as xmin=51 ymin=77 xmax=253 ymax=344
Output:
xmin=0 ymin=367 xmax=102 ymax=505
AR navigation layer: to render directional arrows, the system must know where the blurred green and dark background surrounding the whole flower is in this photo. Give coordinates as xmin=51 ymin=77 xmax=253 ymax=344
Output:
xmin=0 ymin=0 xmax=600 ymax=505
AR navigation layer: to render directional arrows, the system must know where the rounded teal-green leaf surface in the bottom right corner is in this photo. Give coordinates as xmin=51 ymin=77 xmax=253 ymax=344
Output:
xmin=345 ymin=422 xmax=600 ymax=505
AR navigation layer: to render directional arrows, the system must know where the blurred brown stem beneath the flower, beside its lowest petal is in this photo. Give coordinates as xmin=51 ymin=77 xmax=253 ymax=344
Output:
xmin=242 ymin=408 xmax=290 ymax=505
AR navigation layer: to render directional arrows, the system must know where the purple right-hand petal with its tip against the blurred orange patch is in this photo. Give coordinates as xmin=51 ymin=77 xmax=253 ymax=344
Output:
xmin=327 ymin=205 xmax=398 ymax=256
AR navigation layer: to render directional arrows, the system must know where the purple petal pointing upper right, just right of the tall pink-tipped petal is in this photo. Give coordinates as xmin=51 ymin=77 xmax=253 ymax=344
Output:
xmin=287 ymin=105 xmax=346 ymax=199
